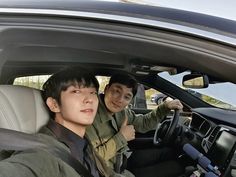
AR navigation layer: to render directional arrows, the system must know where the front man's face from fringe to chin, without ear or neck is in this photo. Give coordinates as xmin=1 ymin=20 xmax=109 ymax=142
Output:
xmin=59 ymin=86 xmax=98 ymax=126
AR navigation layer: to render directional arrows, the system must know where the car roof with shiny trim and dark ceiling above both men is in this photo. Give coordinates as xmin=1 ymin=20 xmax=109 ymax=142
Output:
xmin=0 ymin=0 xmax=236 ymax=83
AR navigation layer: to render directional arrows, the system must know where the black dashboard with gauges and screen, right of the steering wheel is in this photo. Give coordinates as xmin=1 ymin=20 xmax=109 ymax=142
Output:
xmin=189 ymin=111 xmax=236 ymax=177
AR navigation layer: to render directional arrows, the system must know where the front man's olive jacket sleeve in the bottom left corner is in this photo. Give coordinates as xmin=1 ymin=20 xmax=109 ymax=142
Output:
xmin=0 ymin=150 xmax=79 ymax=177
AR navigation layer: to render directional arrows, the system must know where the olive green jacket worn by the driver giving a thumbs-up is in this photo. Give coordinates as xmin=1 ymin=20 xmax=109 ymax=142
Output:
xmin=86 ymin=96 xmax=170 ymax=169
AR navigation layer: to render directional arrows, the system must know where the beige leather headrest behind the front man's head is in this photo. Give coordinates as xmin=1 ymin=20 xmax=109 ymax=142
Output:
xmin=0 ymin=85 xmax=49 ymax=133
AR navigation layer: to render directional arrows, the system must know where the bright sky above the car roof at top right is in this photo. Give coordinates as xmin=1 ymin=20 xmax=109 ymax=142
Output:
xmin=103 ymin=0 xmax=236 ymax=21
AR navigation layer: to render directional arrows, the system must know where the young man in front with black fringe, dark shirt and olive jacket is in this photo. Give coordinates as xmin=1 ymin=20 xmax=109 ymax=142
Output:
xmin=0 ymin=68 xmax=120 ymax=177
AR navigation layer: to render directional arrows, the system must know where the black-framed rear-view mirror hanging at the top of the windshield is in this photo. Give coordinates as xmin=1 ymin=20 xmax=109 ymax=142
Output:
xmin=182 ymin=74 xmax=209 ymax=88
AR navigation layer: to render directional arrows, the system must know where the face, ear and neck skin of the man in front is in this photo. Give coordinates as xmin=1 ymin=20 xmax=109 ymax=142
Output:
xmin=47 ymin=86 xmax=98 ymax=136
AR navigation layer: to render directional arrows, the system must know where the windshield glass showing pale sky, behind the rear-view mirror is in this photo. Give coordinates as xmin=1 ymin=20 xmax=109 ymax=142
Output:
xmin=158 ymin=72 xmax=236 ymax=110
